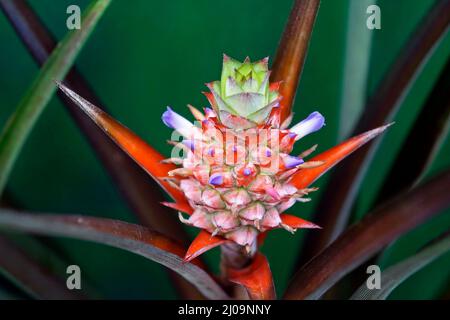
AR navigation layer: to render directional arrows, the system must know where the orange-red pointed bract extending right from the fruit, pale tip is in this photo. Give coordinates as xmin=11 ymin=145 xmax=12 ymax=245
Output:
xmin=291 ymin=124 xmax=391 ymax=189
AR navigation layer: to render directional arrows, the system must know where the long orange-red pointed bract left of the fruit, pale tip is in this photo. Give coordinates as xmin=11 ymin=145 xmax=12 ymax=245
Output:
xmin=58 ymin=83 xmax=187 ymax=210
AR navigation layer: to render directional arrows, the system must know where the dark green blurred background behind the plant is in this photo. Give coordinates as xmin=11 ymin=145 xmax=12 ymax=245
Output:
xmin=0 ymin=0 xmax=450 ymax=299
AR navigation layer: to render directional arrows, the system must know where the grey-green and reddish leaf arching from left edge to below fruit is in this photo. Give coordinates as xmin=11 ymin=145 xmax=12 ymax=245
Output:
xmin=0 ymin=209 xmax=228 ymax=299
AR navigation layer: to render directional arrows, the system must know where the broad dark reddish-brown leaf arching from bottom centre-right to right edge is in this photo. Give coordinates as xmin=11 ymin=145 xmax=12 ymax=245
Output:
xmin=285 ymin=171 xmax=450 ymax=299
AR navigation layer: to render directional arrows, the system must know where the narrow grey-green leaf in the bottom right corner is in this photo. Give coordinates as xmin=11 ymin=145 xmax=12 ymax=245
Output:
xmin=350 ymin=234 xmax=450 ymax=300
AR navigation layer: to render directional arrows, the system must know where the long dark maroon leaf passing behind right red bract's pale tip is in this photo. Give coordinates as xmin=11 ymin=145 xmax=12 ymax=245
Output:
xmin=299 ymin=0 xmax=450 ymax=265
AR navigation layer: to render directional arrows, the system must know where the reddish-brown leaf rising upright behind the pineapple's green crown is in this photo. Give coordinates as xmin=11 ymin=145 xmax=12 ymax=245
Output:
xmin=271 ymin=0 xmax=320 ymax=121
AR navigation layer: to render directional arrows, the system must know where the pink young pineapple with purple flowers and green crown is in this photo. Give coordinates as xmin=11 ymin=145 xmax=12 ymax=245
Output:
xmin=162 ymin=55 xmax=324 ymax=254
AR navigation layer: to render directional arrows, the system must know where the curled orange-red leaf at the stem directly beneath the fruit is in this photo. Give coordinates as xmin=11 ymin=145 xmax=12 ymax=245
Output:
xmin=227 ymin=252 xmax=276 ymax=300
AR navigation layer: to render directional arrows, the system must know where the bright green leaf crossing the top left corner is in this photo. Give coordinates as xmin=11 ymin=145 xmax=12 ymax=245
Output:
xmin=0 ymin=0 xmax=110 ymax=194
